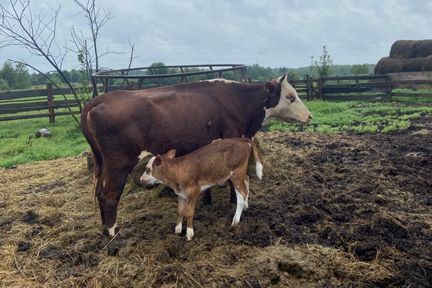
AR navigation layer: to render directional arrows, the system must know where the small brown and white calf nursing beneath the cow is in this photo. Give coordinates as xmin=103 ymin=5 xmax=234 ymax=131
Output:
xmin=140 ymin=138 xmax=263 ymax=241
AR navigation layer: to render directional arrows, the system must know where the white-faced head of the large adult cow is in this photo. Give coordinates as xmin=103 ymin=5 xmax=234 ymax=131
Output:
xmin=264 ymin=74 xmax=312 ymax=123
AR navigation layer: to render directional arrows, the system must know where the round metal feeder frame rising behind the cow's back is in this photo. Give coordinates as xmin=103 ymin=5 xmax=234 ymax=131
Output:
xmin=92 ymin=64 xmax=247 ymax=96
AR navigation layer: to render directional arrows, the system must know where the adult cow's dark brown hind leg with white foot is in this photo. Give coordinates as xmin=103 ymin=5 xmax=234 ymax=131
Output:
xmin=97 ymin=167 xmax=130 ymax=236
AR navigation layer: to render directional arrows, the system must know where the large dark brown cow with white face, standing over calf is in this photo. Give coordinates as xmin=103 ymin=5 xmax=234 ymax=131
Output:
xmin=81 ymin=75 xmax=312 ymax=235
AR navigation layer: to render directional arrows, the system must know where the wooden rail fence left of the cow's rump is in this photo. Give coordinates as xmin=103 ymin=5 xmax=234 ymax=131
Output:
xmin=0 ymin=84 xmax=79 ymax=122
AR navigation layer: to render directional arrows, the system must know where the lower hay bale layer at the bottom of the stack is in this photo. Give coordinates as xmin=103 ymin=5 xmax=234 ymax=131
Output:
xmin=374 ymin=56 xmax=432 ymax=74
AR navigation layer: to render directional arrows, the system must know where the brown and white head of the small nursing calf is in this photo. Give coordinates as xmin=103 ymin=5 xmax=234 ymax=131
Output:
xmin=140 ymin=149 xmax=176 ymax=185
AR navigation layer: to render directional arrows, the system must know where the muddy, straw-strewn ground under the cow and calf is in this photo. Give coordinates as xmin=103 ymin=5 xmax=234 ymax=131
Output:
xmin=0 ymin=118 xmax=432 ymax=287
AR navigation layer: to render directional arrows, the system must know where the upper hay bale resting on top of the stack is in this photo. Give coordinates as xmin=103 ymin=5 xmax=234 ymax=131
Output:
xmin=390 ymin=40 xmax=432 ymax=58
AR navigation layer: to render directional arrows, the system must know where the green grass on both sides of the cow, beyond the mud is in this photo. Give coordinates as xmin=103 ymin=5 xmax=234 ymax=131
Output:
xmin=0 ymin=101 xmax=432 ymax=167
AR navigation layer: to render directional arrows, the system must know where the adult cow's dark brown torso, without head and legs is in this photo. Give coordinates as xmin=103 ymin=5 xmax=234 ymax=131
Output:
xmin=83 ymin=82 xmax=263 ymax=161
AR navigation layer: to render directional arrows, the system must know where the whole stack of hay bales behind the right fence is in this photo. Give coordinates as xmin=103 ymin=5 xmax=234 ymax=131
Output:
xmin=375 ymin=40 xmax=432 ymax=74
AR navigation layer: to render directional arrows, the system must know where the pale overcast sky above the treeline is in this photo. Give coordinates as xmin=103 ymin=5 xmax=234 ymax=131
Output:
xmin=0 ymin=0 xmax=432 ymax=70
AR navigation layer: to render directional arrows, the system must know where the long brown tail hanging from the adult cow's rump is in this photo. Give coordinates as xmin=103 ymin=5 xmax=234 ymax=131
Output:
xmin=81 ymin=102 xmax=102 ymax=203
